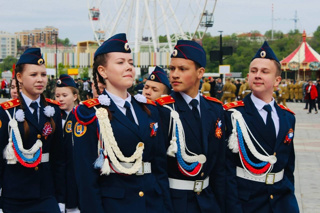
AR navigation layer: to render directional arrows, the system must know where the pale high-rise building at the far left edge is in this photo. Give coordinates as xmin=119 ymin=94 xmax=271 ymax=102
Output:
xmin=0 ymin=31 xmax=17 ymax=60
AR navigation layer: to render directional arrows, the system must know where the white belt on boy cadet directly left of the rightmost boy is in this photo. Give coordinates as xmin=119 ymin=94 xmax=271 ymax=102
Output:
xmin=169 ymin=177 xmax=209 ymax=192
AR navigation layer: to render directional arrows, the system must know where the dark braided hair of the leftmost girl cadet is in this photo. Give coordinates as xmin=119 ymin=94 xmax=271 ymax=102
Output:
xmin=14 ymin=64 xmax=56 ymax=139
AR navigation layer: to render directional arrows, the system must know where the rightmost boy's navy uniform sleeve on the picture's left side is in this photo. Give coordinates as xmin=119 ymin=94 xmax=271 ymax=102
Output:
xmin=224 ymin=111 xmax=242 ymax=213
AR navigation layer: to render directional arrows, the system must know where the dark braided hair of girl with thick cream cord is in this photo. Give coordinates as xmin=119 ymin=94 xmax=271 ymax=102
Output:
xmin=92 ymin=53 xmax=151 ymax=116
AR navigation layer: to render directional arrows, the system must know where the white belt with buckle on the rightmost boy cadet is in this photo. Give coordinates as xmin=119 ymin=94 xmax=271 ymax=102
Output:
xmin=237 ymin=166 xmax=284 ymax=185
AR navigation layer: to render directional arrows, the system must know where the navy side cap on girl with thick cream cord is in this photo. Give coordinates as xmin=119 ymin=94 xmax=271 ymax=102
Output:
xmin=94 ymin=33 xmax=131 ymax=58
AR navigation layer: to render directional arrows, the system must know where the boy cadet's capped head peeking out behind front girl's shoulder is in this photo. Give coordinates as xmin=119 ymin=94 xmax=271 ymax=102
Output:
xmin=142 ymin=66 xmax=171 ymax=101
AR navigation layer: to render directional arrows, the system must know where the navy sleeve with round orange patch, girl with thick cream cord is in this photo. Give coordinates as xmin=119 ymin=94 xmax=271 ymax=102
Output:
xmin=72 ymin=107 xmax=104 ymax=213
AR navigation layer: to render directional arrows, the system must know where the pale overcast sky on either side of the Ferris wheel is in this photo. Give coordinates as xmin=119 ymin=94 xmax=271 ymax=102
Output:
xmin=0 ymin=0 xmax=320 ymax=44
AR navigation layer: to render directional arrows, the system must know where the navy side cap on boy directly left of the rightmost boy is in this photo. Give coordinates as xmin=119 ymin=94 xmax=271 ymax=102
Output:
xmin=171 ymin=40 xmax=207 ymax=67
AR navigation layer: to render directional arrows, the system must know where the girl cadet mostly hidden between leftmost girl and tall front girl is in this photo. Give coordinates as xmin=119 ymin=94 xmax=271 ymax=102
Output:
xmin=55 ymin=74 xmax=80 ymax=213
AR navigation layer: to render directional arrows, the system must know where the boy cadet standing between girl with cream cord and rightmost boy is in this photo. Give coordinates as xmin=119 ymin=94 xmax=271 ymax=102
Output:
xmin=157 ymin=40 xmax=225 ymax=213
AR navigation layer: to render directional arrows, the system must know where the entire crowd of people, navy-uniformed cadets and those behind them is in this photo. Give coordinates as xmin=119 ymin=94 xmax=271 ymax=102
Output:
xmin=0 ymin=34 xmax=310 ymax=213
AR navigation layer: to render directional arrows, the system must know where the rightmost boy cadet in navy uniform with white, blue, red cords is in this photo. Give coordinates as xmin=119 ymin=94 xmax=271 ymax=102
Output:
xmin=224 ymin=42 xmax=299 ymax=213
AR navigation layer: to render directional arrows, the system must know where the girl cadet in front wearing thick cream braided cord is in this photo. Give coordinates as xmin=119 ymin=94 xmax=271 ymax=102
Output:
xmin=73 ymin=34 xmax=172 ymax=213
